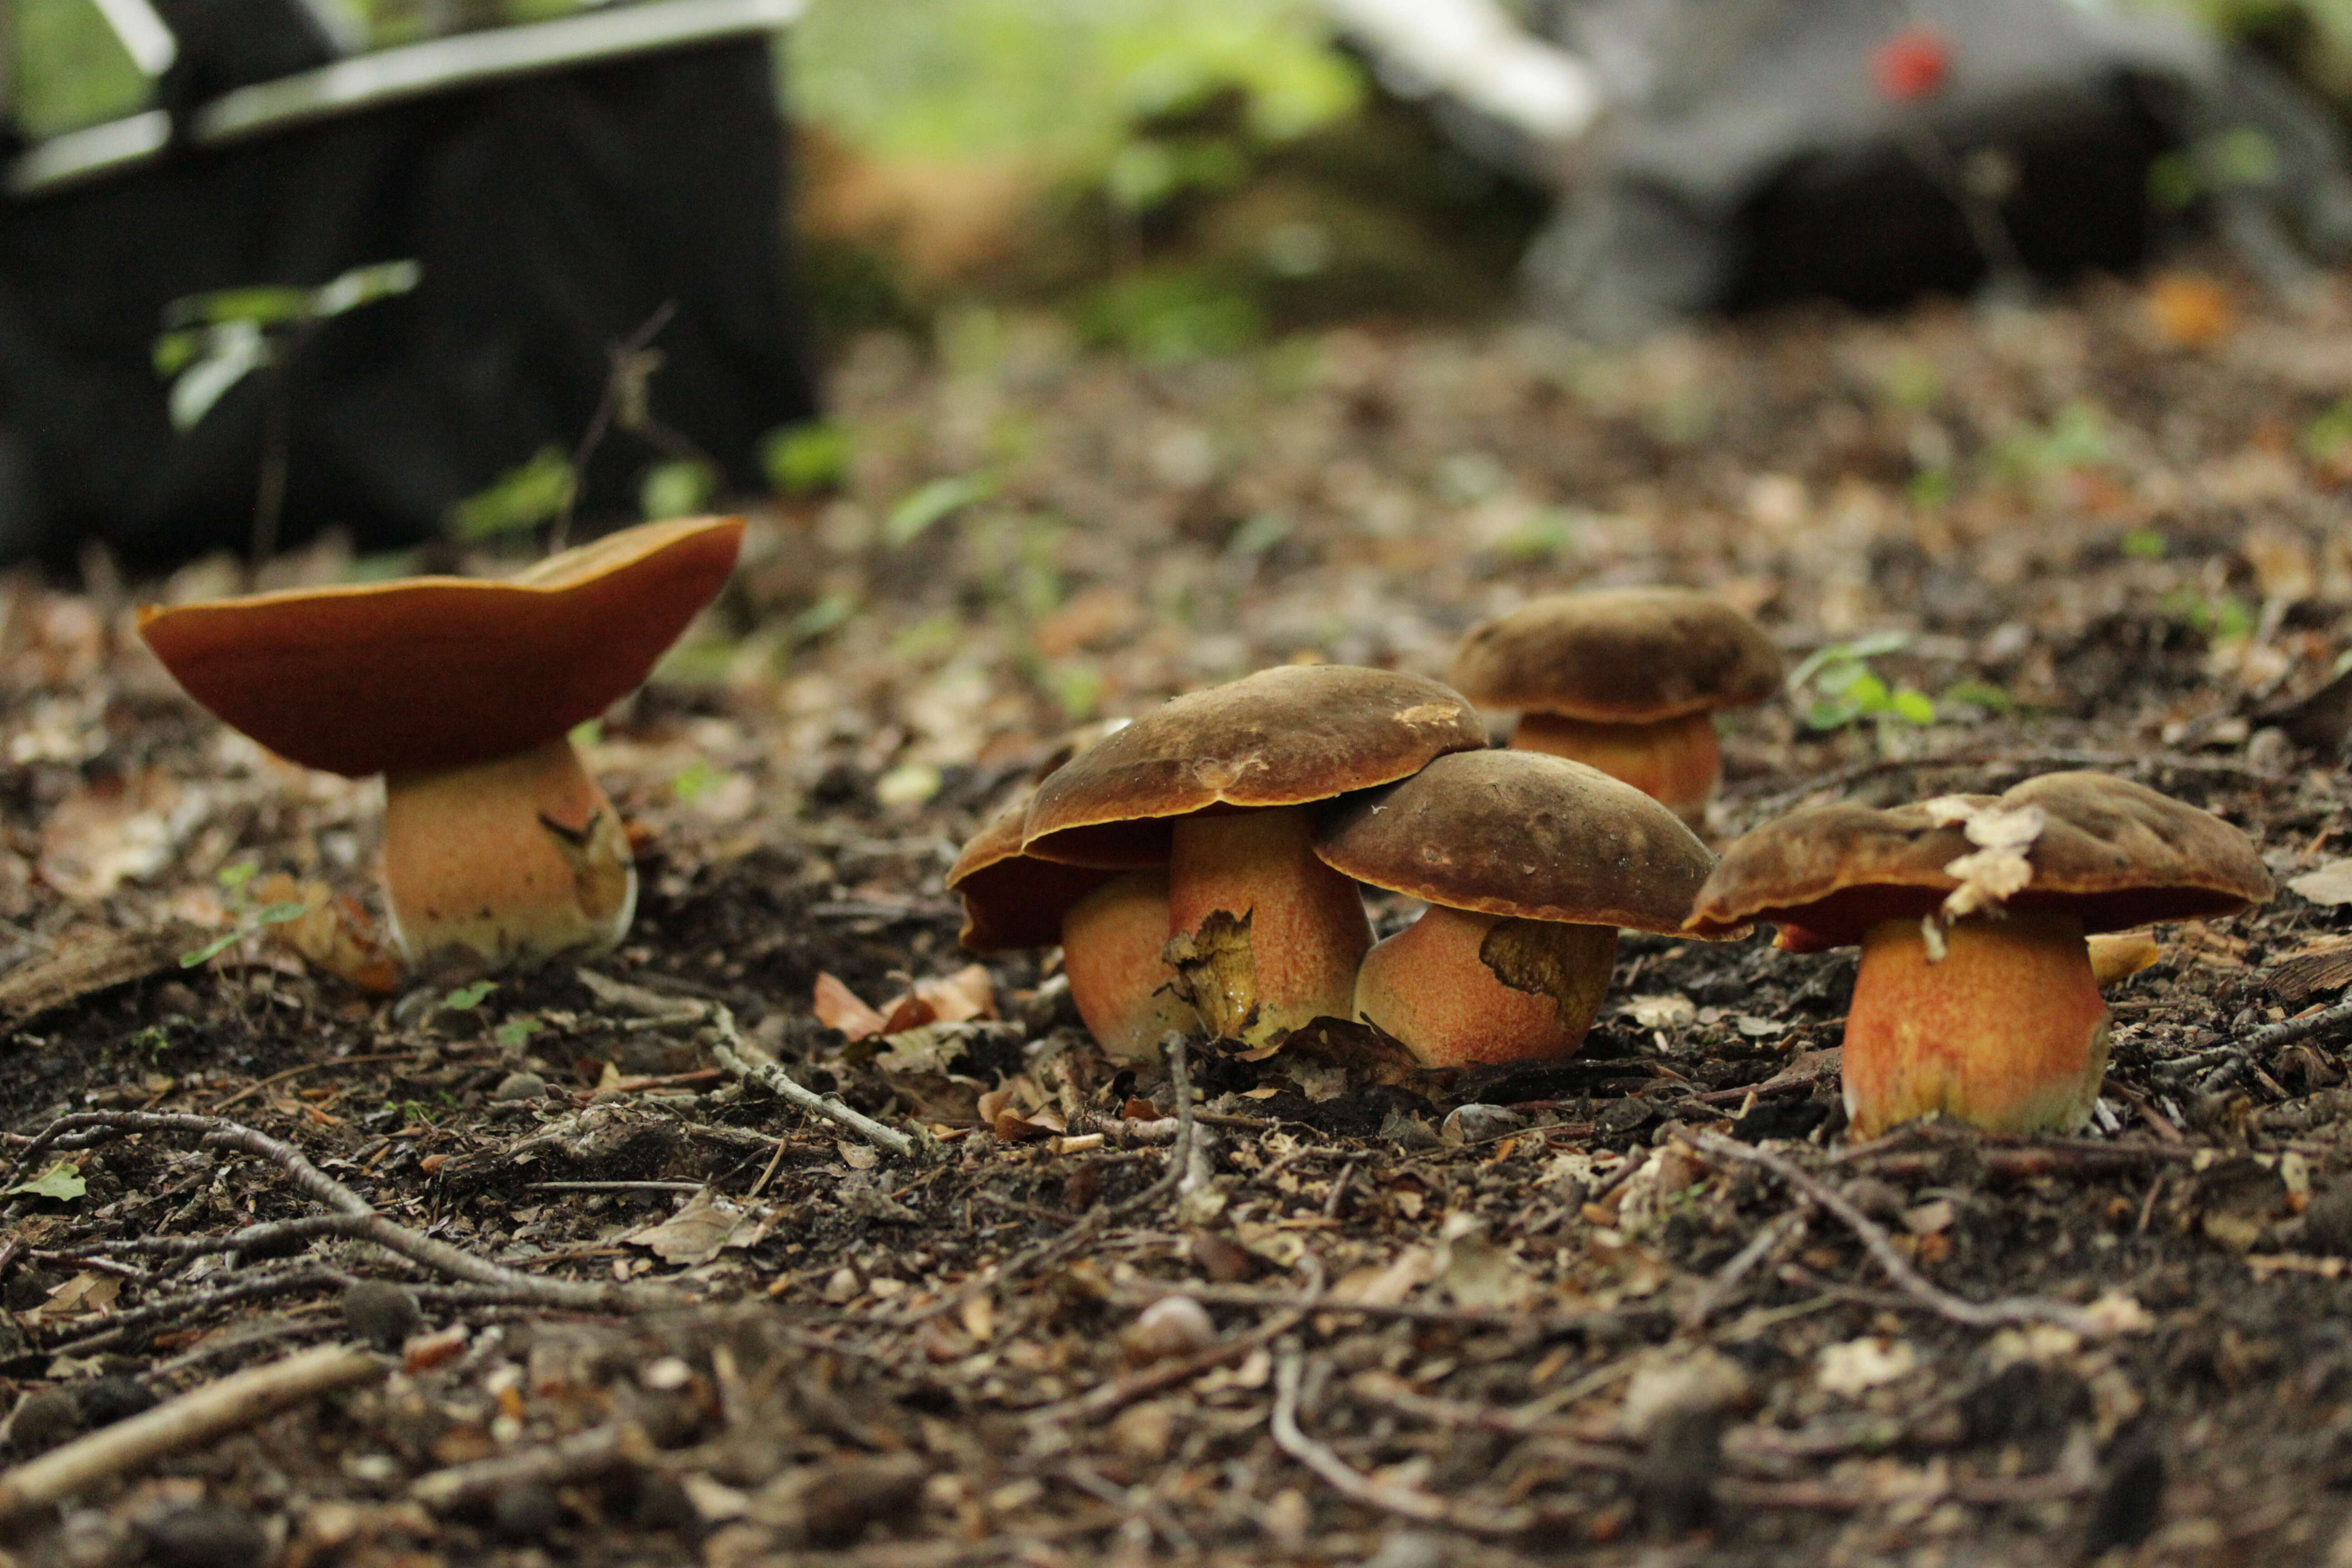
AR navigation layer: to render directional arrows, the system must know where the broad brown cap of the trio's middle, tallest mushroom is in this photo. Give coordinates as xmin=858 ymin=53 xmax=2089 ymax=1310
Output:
xmin=1023 ymin=665 xmax=1486 ymax=867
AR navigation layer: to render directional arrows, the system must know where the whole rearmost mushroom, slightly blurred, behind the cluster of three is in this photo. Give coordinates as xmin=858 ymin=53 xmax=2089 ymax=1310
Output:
xmin=1449 ymin=588 xmax=1780 ymax=828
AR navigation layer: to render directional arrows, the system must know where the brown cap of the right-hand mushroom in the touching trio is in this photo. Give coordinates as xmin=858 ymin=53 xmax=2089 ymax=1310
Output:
xmin=1315 ymin=752 xmax=1715 ymax=931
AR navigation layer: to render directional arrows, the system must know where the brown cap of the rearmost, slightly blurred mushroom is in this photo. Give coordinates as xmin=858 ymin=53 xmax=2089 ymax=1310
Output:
xmin=1446 ymin=588 xmax=1780 ymax=724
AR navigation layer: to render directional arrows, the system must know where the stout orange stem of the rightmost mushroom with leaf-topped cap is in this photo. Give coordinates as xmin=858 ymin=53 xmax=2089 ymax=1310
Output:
xmin=1844 ymin=912 xmax=2107 ymax=1138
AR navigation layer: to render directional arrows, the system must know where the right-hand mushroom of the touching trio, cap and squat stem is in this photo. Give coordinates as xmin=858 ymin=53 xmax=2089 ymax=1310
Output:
xmin=1315 ymin=752 xmax=1715 ymax=1067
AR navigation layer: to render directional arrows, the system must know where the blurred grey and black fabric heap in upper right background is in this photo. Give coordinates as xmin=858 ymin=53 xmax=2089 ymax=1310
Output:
xmin=1489 ymin=0 xmax=2352 ymax=338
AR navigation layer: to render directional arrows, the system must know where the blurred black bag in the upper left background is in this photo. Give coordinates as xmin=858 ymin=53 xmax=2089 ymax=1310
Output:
xmin=0 ymin=35 xmax=816 ymax=567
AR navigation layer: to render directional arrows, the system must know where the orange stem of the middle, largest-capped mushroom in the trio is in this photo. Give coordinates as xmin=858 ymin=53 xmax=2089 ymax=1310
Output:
xmin=1169 ymin=806 xmax=1371 ymax=1044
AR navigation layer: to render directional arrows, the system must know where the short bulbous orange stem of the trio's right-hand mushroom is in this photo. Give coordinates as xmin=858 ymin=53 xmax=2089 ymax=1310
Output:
xmin=1355 ymin=905 xmax=1616 ymax=1067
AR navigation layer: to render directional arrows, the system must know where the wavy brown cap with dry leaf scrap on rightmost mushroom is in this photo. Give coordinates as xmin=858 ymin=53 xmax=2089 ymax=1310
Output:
xmin=1689 ymin=774 xmax=2274 ymax=947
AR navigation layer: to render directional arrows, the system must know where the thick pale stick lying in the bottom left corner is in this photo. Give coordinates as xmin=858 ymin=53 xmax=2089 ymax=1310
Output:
xmin=0 ymin=1345 xmax=391 ymax=1519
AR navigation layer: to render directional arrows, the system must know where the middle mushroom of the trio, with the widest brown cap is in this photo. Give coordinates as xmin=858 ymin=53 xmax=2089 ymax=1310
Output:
xmin=1021 ymin=665 xmax=1486 ymax=1041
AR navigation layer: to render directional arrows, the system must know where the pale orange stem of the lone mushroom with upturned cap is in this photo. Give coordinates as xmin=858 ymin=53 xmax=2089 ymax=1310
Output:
xmin=383 ymin=738 xmax=637 ymax=966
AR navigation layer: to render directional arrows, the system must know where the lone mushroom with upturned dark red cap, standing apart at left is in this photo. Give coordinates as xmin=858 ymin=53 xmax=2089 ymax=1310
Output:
xmin=139 ymin=517 xmax=743 ymax=966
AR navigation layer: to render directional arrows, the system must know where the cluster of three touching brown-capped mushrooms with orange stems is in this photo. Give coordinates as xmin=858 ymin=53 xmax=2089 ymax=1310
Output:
xmin=948 ymin=665 xmax=1712 ymax=1065
